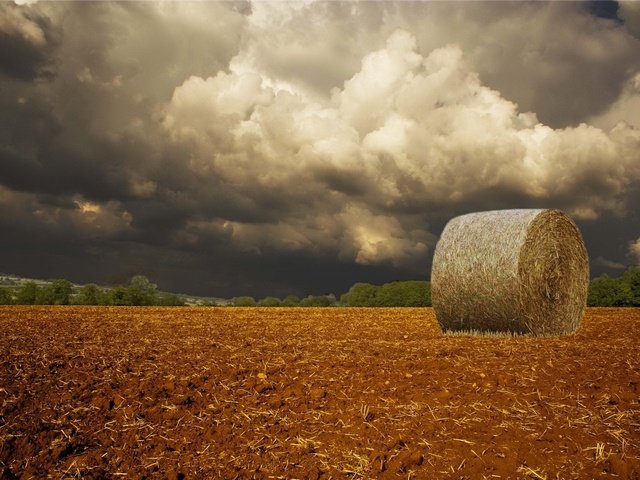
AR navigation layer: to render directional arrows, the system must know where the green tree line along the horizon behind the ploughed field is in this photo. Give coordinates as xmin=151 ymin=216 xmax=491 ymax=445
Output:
xmin=0 ymin=266 xmax=640 ymax=307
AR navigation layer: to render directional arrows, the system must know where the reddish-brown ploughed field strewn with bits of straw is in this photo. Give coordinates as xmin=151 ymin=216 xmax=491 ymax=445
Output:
xmin=0 ymin=307 xmax=640 ymax=479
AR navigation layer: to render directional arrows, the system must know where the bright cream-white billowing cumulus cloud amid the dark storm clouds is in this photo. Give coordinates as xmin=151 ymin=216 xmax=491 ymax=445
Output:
xmin=164 ymin=29 xmax=640 ymax=264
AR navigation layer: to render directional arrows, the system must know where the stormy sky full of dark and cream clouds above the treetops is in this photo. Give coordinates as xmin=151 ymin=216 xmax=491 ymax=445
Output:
xmin=0 ymin=0 xmax=640 ymax=298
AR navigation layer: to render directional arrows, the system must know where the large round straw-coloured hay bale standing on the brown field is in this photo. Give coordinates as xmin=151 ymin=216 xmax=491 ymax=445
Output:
xmin=431 ymin=210 xmax=589 ymax=335
